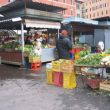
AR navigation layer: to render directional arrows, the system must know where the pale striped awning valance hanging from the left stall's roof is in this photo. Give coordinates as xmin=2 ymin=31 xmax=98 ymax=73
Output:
xmin=25 ymin=19 xmax=61 ymax=29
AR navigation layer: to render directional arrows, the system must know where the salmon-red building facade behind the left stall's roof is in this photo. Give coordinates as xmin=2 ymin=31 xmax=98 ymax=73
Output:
xmin=0 ymin=0 xmax=76 ymax=18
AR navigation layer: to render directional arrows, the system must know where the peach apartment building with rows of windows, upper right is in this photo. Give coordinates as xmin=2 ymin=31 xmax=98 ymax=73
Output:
xmin=82 ymin=0 xmax=110 ymax=19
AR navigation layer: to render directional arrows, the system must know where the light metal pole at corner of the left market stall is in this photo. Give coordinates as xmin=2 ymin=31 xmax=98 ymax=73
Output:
xmin=21 ymin=22 xmax=24 ymax=65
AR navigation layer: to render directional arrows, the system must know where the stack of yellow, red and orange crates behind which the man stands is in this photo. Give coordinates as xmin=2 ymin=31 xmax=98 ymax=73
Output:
xmin=47 ymin=59 xmax=76 ymax=89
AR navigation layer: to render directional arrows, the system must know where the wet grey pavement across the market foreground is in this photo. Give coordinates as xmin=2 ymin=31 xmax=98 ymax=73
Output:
xmin=0 ymin=65 xmax=110 ymax=110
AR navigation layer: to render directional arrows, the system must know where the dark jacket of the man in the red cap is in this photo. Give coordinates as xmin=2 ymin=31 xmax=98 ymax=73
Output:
xmin=56 ymin=36 xmax=72 ymax=59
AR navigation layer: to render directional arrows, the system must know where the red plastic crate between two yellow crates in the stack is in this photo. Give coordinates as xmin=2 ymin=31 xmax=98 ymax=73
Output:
xmin=53 ymin=72 xmax=63 ymax=87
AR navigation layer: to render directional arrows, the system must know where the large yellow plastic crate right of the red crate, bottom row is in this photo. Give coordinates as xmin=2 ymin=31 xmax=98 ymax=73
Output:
xmin=63 ymin=73 xmax=76 ymax=89
